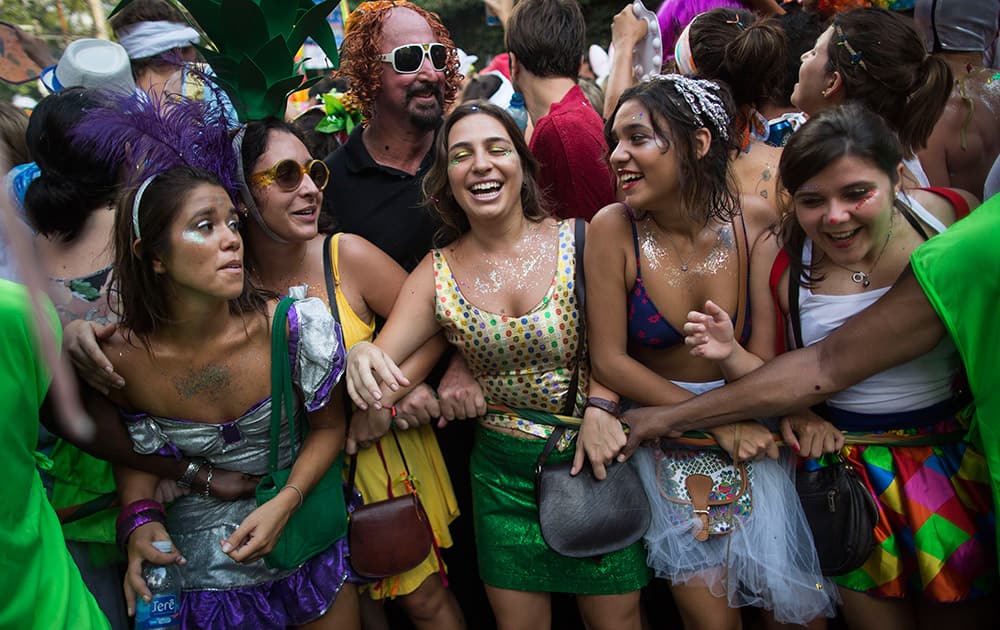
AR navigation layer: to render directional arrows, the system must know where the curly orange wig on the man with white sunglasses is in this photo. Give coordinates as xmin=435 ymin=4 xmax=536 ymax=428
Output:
xmin=336 ymin=0 xmax=462 ymax=121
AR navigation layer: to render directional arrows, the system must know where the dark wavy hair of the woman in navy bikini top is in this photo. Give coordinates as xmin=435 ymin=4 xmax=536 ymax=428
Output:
xmin=604 ymin=75 xmax=740 ymax=225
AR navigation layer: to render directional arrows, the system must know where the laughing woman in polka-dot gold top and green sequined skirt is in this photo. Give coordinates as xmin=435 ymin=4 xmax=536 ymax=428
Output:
xmin=348 ymin=101 xmax=649 ymax=630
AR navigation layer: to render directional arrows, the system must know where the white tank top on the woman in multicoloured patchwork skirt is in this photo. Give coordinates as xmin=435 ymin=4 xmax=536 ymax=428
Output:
xmin=799 ymin=197 xmax=961 ymax=414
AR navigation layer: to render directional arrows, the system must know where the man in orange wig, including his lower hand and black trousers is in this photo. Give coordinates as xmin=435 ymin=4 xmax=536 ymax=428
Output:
xmin=323 ymin=1 xmax=493 ymax=628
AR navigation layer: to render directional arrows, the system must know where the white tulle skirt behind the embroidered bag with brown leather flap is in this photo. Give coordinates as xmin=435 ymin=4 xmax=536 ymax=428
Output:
xmin=634 ymin=383 xmax=838 ymax=624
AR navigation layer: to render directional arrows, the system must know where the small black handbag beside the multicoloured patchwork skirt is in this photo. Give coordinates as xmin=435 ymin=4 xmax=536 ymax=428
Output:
xmin=795 ymin=458 xmax=878 ymax=575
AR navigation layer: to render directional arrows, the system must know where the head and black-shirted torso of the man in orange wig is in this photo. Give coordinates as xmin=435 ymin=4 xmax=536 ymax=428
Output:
xmin=323 ymin=2 xmax=461 ymax=271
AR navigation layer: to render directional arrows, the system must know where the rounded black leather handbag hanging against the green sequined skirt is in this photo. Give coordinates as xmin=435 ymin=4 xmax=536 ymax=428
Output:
xmin=535 ymin=427 xmax=652 ymax=558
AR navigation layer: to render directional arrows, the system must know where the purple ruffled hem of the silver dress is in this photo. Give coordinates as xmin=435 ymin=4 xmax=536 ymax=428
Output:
xmin=181 ymin=538 xmax=350 ymax=630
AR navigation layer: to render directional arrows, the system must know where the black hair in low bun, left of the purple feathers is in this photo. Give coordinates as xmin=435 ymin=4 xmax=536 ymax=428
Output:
xmin=24 ymin=88 xmax=118 ymax=241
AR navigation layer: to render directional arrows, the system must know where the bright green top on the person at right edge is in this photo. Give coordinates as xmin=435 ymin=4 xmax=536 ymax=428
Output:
xmin=910 ymin=195 xmax=1000 ymax=556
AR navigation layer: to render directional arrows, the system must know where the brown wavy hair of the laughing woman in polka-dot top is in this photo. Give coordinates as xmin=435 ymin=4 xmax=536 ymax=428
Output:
xmin=423 ymin=101 xmax=551 ymax=246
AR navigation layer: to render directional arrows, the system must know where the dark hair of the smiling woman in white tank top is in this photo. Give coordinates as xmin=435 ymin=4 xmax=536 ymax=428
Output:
xmin=778 ymin=103 xmax=912 ymax=288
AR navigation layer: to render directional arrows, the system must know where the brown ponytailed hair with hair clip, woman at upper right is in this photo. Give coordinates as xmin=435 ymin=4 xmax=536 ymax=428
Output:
xmin=826 ymin=8 xmax=954 ymax=156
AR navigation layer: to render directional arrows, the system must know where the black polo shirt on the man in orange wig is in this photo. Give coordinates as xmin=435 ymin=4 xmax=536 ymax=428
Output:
xmin=323 ymin=125 xmax=440 ymax=272
